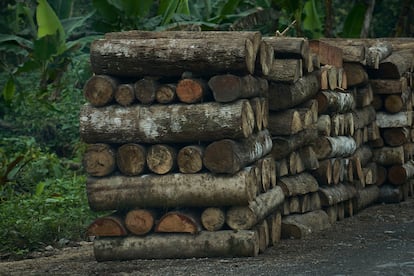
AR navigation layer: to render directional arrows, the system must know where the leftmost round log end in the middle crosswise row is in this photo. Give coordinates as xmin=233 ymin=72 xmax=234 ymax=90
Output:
xmin=82 ymin=144 xmax=116 ymax=176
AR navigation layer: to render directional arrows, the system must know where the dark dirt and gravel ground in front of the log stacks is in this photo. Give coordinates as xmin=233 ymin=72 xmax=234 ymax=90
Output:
xmin=0 ymin=198 xmax=414 ymax=275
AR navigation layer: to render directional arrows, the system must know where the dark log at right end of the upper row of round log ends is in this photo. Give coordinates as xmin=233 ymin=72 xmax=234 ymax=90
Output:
xmin=208 ymin=74 xmax=268 ymax=103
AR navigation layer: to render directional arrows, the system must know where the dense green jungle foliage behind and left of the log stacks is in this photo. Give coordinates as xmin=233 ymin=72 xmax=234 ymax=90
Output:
xmin=0 ymin=0 xmax=414 ymax=258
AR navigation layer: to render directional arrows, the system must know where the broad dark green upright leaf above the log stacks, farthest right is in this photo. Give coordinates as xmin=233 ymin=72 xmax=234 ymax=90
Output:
xmin=342 ymin=3 xmax=367 ymax=38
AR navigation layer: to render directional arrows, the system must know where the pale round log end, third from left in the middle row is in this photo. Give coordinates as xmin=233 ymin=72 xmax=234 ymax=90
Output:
xmin=147 ymin=144 xmax=177 ymax=174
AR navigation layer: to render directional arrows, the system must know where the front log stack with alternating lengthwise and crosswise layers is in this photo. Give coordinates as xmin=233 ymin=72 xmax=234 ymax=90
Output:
xmin=80 ymin=31 xmax=284 ymax=261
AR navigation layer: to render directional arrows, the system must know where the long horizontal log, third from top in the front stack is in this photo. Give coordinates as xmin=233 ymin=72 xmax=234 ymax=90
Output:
xmin=86 ymin=167 xmax=257 ymax=211
